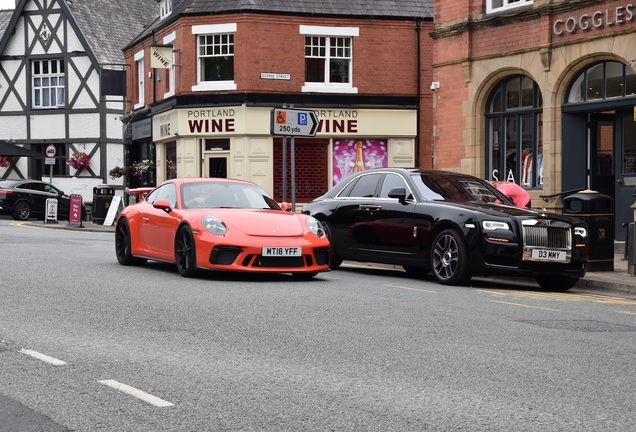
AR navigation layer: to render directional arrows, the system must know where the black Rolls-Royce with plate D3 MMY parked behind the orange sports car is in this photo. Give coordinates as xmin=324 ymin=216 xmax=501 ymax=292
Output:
xmin=302 ymin=168 xmax=588 ymax=291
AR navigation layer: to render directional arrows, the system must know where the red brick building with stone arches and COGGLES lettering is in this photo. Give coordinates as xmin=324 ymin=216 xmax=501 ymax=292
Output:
xmin=431 ymin=0 xmax=636 ymax=239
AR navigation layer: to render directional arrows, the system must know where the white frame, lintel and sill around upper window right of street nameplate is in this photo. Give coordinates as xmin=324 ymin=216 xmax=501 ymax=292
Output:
xmin=300 ymin=25 xmax=360 ymax=93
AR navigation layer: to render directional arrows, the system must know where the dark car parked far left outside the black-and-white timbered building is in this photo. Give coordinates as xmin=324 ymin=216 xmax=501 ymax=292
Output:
xmin=0 ymin=180 xmax=86 ymax=220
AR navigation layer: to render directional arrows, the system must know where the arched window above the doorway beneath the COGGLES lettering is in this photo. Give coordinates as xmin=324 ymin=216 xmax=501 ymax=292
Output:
xmin=565 ymin=61 xmax=636 ymax=103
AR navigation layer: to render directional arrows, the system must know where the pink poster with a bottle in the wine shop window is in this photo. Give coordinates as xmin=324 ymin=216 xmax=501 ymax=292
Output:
xmin=332 ymin=139 xmax=389 ymax=185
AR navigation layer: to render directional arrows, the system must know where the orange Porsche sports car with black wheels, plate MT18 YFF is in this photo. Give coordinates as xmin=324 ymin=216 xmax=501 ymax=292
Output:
xmin=115 ymin=178 xmax=329 ymax=278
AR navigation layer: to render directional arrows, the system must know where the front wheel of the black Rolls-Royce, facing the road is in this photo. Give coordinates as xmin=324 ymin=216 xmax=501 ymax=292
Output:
xmin=431 ymin=229 xmax=470 ymax=285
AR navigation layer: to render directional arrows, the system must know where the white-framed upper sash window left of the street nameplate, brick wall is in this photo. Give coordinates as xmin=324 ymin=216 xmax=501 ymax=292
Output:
xmin=192 ymin=24 xmax=236 ymax=91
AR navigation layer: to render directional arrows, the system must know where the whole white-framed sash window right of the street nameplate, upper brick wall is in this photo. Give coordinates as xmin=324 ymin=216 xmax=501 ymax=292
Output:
xmin=300 ymin=26 xmax=359 ymax=93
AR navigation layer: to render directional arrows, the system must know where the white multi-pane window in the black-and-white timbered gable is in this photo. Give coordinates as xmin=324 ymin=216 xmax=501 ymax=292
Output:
xmin=31 ymin=59 xmax=66 ymax=108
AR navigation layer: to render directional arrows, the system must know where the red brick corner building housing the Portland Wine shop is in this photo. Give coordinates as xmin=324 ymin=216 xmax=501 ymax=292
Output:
xmin=124 ymin=0 xmax=433 ymax=206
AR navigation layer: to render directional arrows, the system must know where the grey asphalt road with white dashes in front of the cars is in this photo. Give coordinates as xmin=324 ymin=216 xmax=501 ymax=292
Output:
xmin=0 ymin=219 xmax=636 ymax=432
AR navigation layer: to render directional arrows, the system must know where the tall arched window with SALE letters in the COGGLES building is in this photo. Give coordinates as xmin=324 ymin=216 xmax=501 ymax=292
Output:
xmin=486 ymin=75 xmax=543 ymax=189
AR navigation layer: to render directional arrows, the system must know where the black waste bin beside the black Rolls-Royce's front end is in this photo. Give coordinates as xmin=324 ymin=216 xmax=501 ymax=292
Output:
xmin=563 ymin=189 xmax=615 ymax=271
